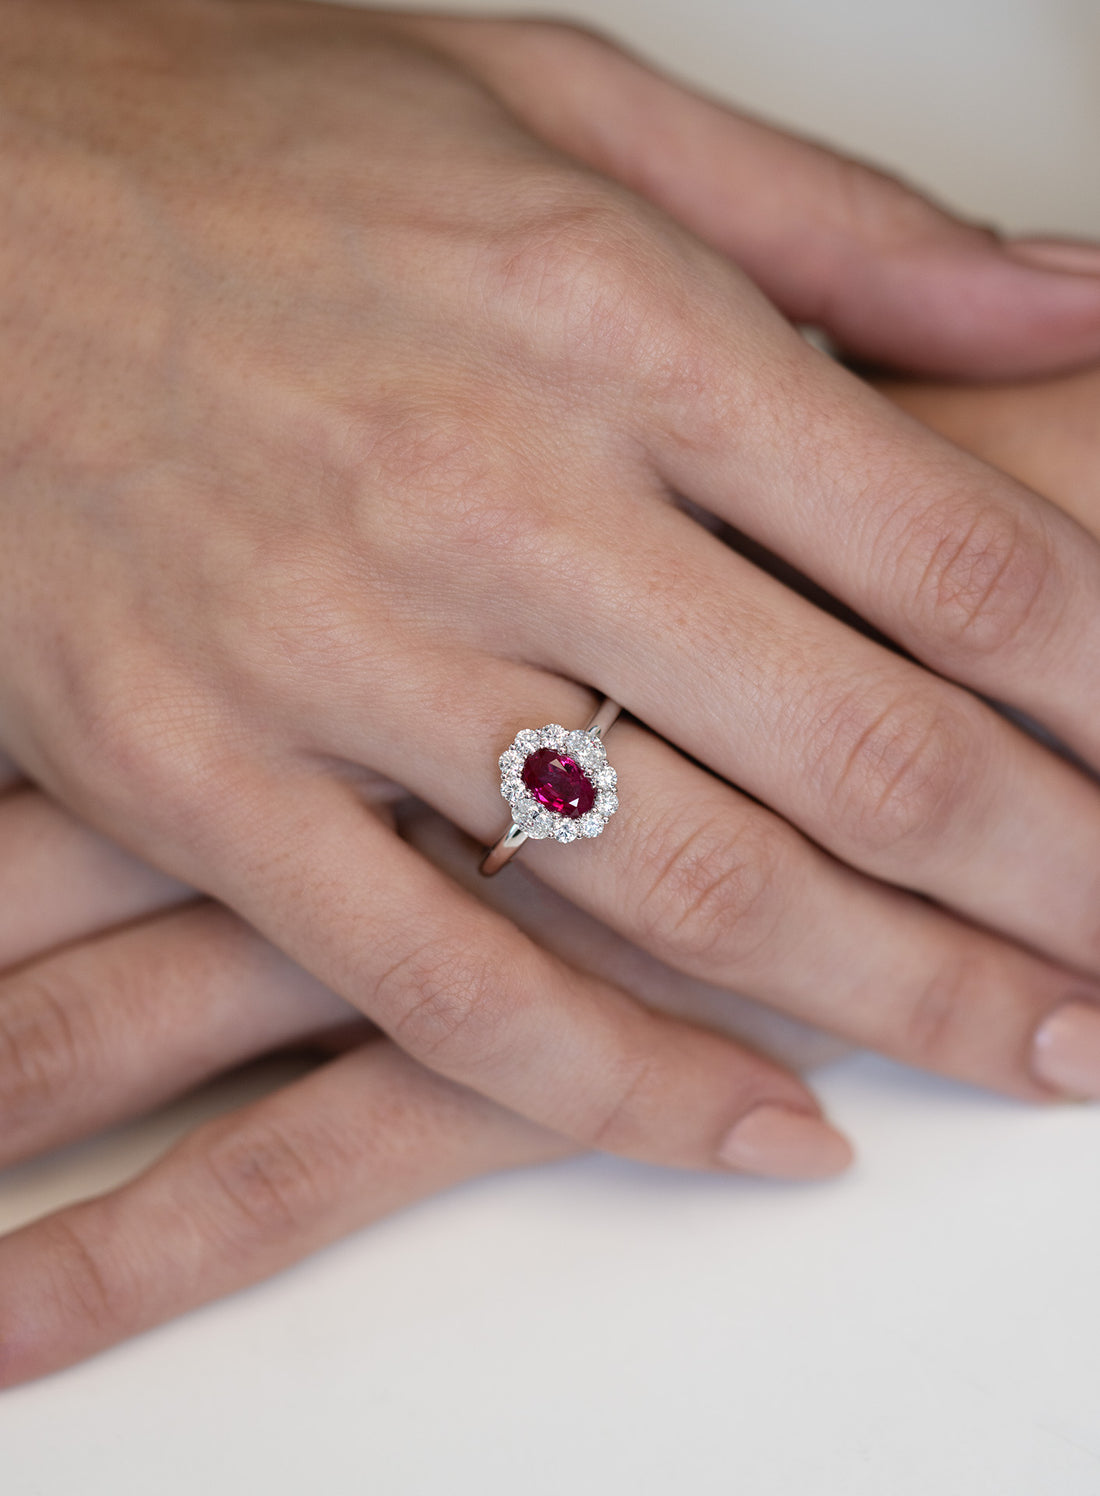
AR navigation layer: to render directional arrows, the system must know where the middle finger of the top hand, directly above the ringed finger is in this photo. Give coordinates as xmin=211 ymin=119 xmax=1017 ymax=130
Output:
xmin=535 ymin=490 xmax=1100 ymax=971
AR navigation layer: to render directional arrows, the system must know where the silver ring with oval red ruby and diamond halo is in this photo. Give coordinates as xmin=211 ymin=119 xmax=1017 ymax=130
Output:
xmin=482 ymin=699 xmax=620 ymax=877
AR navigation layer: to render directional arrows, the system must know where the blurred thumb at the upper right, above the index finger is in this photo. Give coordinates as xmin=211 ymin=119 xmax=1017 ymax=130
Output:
xmin=430 ymin=19 xmax=1100 ymax=378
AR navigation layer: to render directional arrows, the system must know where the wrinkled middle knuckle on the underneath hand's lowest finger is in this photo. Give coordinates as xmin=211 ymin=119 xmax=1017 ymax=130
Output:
xmin=204 ymin=1122 xmax=325 ymax=1252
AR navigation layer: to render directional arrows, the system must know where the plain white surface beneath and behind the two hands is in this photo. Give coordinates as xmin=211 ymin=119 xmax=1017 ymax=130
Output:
xmin=0 ymin=0 xmax=1100 ymax=1496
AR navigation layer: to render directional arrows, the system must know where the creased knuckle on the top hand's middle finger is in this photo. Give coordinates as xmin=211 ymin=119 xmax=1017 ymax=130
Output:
xmin=810 ymin=687 xmax=977 ymax=857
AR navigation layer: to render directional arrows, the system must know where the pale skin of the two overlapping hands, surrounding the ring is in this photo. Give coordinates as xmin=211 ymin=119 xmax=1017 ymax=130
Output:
xmin=0 ymin=0 xmax=1100 ymax=1381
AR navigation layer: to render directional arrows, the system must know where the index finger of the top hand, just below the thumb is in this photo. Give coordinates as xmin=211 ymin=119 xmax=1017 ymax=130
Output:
xmin=650 ymin=311 xmax=1100 ymax=766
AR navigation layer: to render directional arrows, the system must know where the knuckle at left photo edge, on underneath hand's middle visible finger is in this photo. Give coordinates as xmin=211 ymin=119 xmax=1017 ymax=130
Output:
xmin=0 ymin=971 xmax=94 ymax=1131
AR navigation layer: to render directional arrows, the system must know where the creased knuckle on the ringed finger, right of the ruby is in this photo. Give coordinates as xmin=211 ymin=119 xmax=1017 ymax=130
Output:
xmin=639 ymin=814 xmax=787 ymax=971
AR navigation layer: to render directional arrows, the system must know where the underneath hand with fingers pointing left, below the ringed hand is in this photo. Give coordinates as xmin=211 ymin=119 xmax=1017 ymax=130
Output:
xmin=0 ymin=788 xmax=823 ymax=1387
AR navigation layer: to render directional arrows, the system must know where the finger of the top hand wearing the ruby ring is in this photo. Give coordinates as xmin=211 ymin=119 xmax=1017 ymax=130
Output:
xmin=318 ymin=657 xmax=1100 ymax=1100
